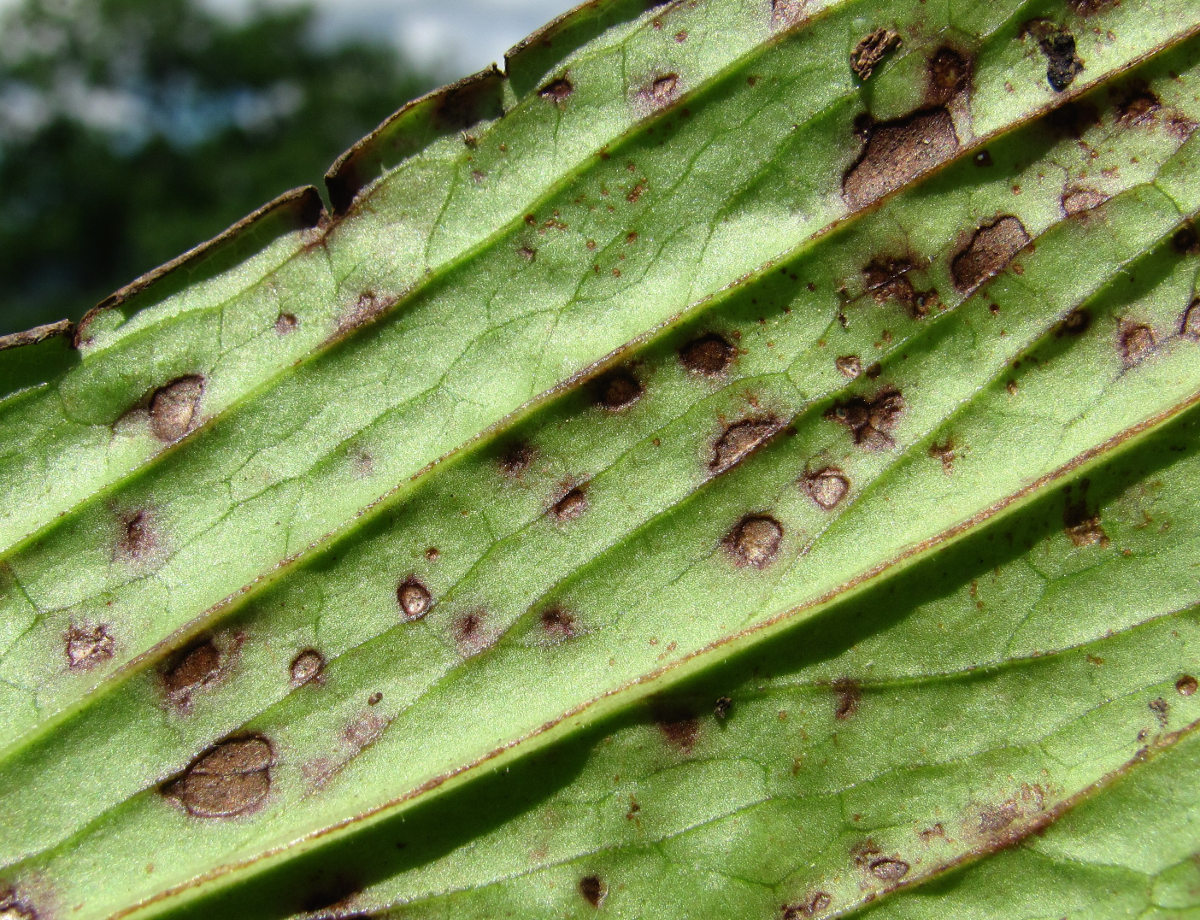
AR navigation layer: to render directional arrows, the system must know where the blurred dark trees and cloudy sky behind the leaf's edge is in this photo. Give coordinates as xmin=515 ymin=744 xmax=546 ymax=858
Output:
xmin=0 ymin=0 xmax=574 ymax=335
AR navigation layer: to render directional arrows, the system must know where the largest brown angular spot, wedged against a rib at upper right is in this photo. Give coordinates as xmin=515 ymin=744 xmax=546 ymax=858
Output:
xmin=841 ymin=107 xmax=959 ymax=208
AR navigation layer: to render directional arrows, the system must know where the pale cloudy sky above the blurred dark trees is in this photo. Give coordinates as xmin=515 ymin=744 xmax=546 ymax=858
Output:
xmin=199 ymin=0 xmax=575 ymax=79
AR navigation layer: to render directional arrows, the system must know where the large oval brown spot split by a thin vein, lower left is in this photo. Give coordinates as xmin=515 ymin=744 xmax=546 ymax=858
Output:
xmin=162 ymin=735 xmax=275 ymax=818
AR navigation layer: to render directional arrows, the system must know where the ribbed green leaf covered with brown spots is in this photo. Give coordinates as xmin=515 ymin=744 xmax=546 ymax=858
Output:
xmin=0 ymin=0 xmax=1200 ymax=920
